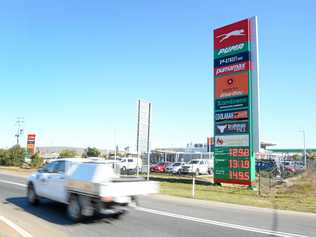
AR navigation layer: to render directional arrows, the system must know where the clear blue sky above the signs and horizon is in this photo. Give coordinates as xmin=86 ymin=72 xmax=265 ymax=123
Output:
xmin=0 ymin=0 xmax=316 ymax=148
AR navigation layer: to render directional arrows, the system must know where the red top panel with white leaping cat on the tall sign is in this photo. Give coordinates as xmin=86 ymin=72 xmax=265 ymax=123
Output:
xmin=214 ymin=19 xmax=250 ymax=49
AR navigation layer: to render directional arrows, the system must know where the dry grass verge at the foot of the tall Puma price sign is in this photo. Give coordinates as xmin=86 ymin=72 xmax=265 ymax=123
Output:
xmin=153 ymin=171 xmax=316 ymax=213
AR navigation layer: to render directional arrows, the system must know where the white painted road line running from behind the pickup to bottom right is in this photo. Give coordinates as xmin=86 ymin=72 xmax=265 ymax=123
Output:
xmin=136 ymin=207 xmax=307 ymax=237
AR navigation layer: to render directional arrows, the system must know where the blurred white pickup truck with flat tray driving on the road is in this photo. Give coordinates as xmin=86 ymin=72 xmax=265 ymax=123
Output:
xmin=27 ymin=158 xmax=159 ymax=221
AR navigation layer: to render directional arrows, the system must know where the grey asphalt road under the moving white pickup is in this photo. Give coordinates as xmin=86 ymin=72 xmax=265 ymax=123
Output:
xmin=0 ymin=174 xmax=316 ymax=237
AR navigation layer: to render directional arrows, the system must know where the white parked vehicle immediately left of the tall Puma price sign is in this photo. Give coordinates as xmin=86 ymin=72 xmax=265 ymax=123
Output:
xmin=181 ymin=159 xmax=213 ymax=175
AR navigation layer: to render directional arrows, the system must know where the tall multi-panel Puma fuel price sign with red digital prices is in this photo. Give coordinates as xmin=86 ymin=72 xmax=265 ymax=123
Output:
xmin=214 ymin=17 xmax=259 ymax=186
